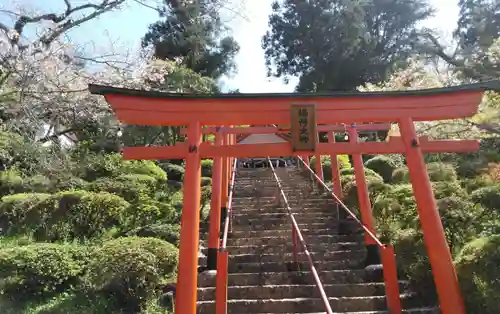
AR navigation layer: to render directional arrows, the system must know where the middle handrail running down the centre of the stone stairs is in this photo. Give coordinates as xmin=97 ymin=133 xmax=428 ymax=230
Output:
xmin=268 ymin=157 xmax=333 ymax=314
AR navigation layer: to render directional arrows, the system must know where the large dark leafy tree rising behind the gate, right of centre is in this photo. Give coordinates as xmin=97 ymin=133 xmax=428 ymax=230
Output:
xmin=262 ymin=0 xmax=432 ymax=91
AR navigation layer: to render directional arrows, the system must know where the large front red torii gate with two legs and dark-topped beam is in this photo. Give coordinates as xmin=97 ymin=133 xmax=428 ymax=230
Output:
xmin=89 ymin=82 xmax=497 ymax=314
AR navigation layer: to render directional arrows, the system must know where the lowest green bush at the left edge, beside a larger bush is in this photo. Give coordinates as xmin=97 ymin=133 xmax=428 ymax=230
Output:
xmin=0 ymin=243 xmax=89 ymax=299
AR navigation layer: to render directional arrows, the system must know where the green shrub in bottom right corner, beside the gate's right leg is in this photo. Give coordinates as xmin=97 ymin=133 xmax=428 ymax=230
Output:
xmin=455 ymin=234 xmax=500 ymax=314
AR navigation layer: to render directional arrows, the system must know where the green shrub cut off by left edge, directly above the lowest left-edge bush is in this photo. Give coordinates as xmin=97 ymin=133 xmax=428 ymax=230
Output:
xmin=0 ymin=193 xmax=51 ymax=235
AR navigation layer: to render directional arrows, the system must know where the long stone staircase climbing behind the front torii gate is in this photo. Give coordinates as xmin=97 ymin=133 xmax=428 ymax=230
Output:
xmin=197 ymin=168 xmax=440 ymax=314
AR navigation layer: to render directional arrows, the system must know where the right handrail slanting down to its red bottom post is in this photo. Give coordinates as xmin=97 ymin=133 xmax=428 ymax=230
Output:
xmin=297 ymin=156 xmax=402 ymax=314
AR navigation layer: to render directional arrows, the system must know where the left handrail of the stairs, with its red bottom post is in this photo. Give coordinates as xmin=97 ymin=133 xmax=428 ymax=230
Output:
xmin=215 ymin=158 xmax=238 ymax=314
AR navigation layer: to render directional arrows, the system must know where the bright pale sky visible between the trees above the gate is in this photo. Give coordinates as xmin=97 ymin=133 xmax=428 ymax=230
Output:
xmin=0 ymin=0 xmax=458 ymax=93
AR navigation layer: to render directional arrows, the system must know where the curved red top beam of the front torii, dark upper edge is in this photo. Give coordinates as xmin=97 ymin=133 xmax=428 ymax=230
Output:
xmin=89 ymin=81 xmax=500 ymax=126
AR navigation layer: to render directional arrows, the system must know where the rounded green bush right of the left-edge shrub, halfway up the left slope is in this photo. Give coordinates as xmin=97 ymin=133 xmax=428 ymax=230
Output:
xmin=36 ymin=191 xmax=130 ymax=240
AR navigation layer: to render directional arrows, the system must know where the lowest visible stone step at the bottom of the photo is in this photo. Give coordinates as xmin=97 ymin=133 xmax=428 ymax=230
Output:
xmin=197 ymin=296 xmax=420 ymax=314
